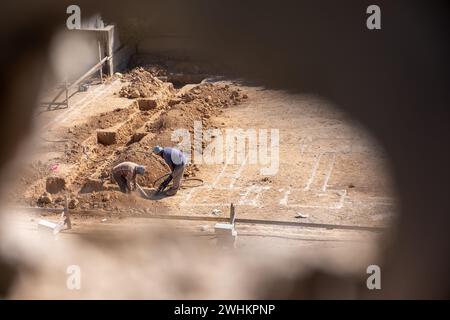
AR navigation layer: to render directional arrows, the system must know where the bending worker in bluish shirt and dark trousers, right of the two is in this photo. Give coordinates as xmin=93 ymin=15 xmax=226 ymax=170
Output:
xmin=153 ymin=146 xmax=187 ymax=196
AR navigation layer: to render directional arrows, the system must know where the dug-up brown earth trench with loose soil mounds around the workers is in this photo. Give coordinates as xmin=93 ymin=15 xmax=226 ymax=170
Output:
xmin=11 ymin=68 xmax=247 ymax=218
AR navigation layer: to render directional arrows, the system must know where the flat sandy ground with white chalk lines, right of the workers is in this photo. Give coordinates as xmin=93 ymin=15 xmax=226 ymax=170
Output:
xmin=170 ymin=87 xmax=395 ymax=225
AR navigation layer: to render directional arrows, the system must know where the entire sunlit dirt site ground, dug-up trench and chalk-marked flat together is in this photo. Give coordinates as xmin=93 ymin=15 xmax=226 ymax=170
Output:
xmin=6 ymin=66 xmax=395 ymax=236
